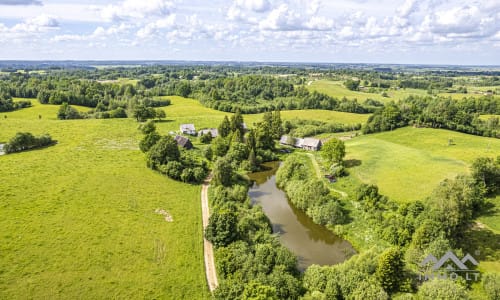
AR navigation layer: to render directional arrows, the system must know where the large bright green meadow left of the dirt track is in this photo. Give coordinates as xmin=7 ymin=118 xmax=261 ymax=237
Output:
xmin=0 ymin=101 xmax=209 ymax=299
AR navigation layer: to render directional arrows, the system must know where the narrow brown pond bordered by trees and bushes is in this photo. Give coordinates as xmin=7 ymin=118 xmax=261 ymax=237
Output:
xmin=248 ymin=162 xmax=356 ymax=270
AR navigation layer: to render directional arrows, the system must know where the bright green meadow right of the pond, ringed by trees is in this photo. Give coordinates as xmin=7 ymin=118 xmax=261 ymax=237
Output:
xmin=330 ymin=127 xmax=500 ymax=202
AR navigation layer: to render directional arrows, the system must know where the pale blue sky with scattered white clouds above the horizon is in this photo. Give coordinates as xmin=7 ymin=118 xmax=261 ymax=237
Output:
xmin=0 ymin=0 xmax=500 ymax=65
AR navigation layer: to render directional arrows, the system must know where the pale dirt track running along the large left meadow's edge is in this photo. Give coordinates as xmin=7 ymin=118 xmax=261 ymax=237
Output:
xmin=201 ymin=177 xmax=219 ymax=292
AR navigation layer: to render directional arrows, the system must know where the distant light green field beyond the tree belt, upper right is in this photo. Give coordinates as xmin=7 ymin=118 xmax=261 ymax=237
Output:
xmin=308 ymin=80 xmax=427 ymax=102
